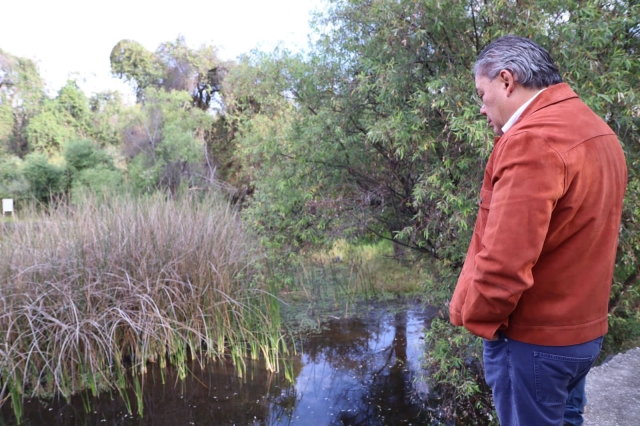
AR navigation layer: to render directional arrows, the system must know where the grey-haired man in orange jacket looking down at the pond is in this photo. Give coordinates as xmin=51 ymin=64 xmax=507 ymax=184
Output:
xmin=449 ymin=36 xmax=627 ymax=426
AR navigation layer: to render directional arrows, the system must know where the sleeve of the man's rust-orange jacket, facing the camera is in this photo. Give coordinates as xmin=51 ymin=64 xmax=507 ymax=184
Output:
xmin=462 ymin=132 xmax=565 ymax=339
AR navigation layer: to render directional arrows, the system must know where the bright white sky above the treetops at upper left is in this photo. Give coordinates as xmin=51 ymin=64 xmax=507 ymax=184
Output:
xmin=0 ymin=0 xmax=324 ymax=95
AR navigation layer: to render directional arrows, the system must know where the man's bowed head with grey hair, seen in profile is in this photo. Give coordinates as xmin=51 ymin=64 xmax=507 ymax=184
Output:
xmin=473 ymin=36 xmax=562 ymax=135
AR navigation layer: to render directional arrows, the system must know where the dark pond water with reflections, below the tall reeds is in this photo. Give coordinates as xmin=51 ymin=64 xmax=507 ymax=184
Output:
xmin=0 ymin=307 xmax=450 ymax=426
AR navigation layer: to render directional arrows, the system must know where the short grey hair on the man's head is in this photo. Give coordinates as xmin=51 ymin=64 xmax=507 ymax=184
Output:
xmin=473 ymin=35 xmax=562 ymax=89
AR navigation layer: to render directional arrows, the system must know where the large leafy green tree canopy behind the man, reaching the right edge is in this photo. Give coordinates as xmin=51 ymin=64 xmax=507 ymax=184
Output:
xmin=231 ymin=0 xmax=640 ymax=280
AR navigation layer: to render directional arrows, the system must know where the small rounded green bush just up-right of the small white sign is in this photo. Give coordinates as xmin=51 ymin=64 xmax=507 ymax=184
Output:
xmin=22 ymin=152 xmax=66 ymax=204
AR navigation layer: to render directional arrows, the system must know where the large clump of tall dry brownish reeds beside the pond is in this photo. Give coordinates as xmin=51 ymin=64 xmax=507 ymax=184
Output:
xmin=0 ymin=195 xmax=286 ymax=419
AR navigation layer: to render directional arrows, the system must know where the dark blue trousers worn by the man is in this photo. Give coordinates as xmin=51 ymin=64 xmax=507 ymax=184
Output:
xmin=484 ymin=334 xmax=603 ymax=426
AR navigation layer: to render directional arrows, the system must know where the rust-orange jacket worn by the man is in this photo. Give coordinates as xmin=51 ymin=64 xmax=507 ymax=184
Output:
xmin=449 ymin=83 xmax=627 ymax=346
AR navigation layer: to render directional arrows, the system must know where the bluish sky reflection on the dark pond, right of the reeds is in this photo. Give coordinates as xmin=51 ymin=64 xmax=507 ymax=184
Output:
xmin=292 ymin=311 xmax=427 ymax=425
